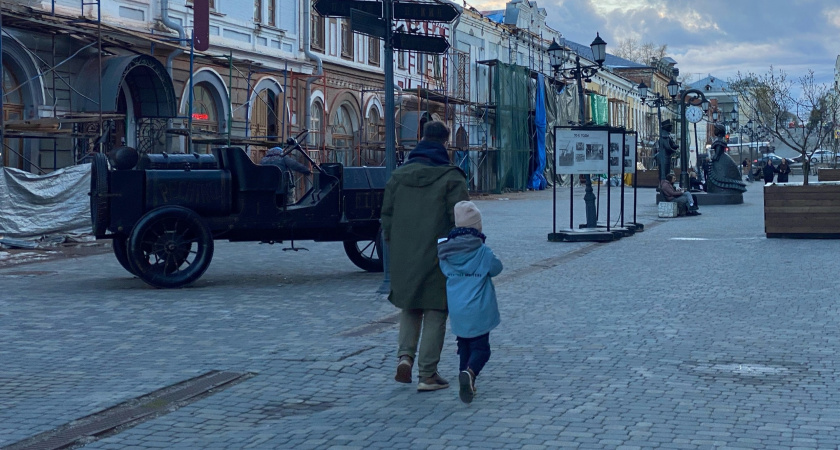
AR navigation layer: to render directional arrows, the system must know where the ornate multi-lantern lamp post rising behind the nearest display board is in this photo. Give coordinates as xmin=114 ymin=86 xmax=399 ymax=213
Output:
xmin=548 ymin=33 xmax=607 ymax=228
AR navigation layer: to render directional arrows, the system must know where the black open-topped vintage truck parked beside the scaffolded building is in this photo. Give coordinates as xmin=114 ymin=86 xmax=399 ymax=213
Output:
xmin=90 ymin=132 xmax=387 ymax=288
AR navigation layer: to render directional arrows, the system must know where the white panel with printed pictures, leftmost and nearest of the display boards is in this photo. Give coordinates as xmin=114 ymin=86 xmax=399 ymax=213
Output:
xmin=554 ymin=127 xmax=617 ymax=175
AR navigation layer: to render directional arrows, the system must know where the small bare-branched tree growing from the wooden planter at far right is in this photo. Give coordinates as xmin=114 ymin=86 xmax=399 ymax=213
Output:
xmin=729 ymin=66 xmax=840 ymax=185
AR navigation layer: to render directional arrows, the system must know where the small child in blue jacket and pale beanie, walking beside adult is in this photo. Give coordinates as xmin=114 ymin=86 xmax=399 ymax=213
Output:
xmin=438 ymin=201 xmax=502 ymax=403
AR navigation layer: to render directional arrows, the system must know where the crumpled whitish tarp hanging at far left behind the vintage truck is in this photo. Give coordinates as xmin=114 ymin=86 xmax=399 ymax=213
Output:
xmin=0 ymin=164 xmax=92 ymax=239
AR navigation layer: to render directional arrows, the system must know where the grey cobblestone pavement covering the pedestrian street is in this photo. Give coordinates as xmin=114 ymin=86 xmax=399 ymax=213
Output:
xmin=0 ymin=178 xmax=840 ymax=449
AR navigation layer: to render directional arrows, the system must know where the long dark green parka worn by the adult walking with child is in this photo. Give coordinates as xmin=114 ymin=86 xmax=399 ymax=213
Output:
xmin=382 ymin=162 xmax=469 ymax=310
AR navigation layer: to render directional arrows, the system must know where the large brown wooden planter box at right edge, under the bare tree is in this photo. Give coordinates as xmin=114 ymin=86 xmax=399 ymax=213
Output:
xmin=764 ymin=182 xmax=840 ymax=239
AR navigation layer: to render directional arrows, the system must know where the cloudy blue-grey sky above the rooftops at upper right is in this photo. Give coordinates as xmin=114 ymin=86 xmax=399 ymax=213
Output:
xmin=467 ymin=0 xmax=840 ymax=87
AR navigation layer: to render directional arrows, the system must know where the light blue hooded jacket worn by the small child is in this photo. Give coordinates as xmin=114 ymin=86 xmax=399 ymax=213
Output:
xmin=438 ymin=235 xmax=502 ymax=338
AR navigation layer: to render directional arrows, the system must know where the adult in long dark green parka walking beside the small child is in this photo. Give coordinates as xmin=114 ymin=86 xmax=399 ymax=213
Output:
xmin=382 ymin=121 xmax=469 ymax=391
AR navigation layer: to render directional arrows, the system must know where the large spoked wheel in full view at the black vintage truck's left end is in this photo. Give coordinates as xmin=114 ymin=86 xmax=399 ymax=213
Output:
xmin=128 ymin=206 xmax=213 ymax=288
